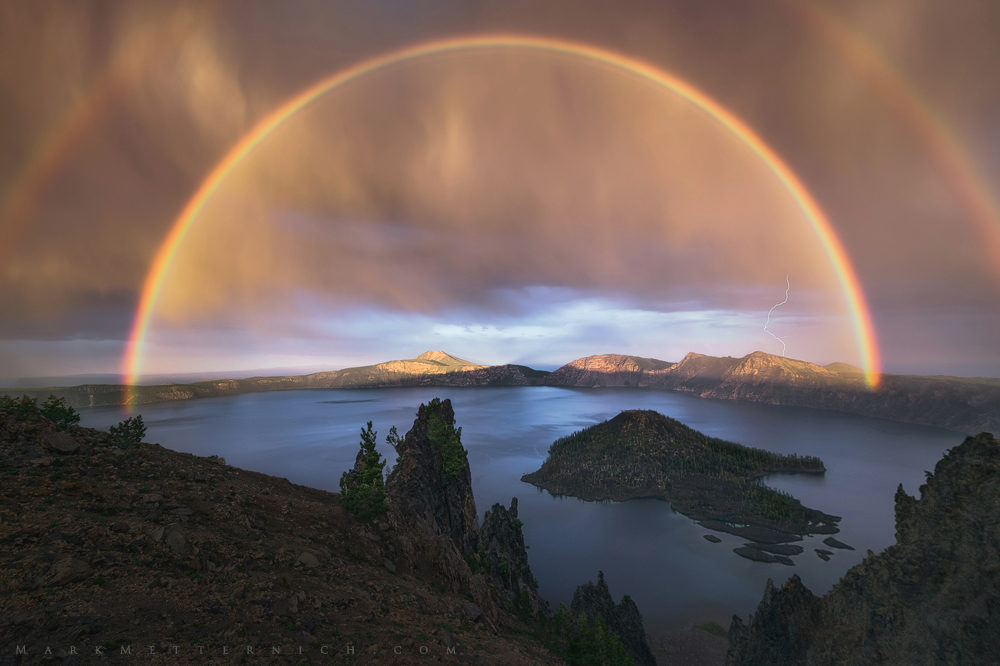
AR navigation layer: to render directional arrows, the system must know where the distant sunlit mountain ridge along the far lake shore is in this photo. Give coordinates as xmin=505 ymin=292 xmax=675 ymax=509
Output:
xmin=0 ymin=350 xmax=1000 ymax=434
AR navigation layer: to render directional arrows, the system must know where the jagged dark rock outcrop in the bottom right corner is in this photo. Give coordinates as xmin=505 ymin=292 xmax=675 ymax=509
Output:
xmin=728 ymin=433 xmax=1000 ymax=664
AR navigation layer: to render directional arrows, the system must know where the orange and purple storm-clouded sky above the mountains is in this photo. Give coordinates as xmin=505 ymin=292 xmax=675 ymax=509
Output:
xmin=0 ymin=0 xmax=1000 ymax=381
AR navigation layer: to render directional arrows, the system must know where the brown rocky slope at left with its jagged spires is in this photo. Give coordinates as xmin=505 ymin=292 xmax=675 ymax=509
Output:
xmin=0 ymin=401 xmax=652 ymax=664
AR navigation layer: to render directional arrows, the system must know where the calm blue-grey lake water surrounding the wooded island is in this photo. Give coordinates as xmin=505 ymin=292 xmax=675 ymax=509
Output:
xmin=83 ymin=387 xmax=962 ymax=634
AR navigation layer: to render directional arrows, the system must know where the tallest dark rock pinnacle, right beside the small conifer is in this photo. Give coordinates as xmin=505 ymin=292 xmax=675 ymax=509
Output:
xmin=385 ymin=398 xmax=479 ymax=557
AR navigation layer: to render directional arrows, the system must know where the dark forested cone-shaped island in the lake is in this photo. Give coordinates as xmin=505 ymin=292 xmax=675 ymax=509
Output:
xmin=521 ymin=410 xmax=840 ymax=548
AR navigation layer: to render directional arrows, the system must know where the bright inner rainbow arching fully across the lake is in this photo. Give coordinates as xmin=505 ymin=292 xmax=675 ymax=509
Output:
xmin=122 ymin=35 xmax=881 ymax=396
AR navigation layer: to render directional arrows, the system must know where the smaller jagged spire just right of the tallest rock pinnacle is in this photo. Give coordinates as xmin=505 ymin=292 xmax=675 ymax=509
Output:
xmin=477 ymin=497 xmax=548 ymax=617
